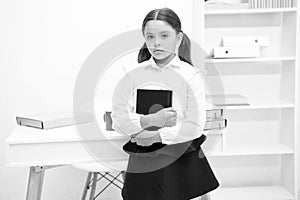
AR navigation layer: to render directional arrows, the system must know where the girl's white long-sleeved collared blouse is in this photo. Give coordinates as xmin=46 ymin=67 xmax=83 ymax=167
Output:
xmin=111 ymin=56 xmax=206 ymax=144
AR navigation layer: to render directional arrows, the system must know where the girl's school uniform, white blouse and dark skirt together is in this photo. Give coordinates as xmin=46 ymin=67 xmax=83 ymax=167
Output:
xmin=111 ymin=56 xmax=219 ymax=200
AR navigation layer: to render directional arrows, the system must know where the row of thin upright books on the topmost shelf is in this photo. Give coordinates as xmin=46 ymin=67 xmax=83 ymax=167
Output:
xmin=249 ymin=0 xmax=296 ymax=9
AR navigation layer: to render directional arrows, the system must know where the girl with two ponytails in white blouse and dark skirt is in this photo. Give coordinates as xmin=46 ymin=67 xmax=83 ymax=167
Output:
xmin=112 ymin=8 xmax=219 ymax=200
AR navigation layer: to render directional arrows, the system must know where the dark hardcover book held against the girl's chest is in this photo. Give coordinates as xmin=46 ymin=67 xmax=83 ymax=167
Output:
xmin=136 ymin=89 xmax=172 ymax=131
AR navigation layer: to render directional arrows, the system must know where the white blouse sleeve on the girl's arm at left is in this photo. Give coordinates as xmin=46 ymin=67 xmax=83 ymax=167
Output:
xmin=111 ymin=74 xmax=143 ymax=136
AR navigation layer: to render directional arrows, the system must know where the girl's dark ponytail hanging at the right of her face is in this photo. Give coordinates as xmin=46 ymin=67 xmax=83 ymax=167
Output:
xmin=178 ymin=32 xmax=193 ymax=66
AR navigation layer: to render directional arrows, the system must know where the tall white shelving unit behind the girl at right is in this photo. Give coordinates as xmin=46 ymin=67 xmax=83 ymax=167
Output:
xmin=193 ymin=0 xmax=300 ymax=200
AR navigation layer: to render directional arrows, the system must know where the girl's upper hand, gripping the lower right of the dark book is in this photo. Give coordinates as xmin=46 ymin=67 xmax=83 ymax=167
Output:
xmin=150 ymin=107 xmax=177 ymax=127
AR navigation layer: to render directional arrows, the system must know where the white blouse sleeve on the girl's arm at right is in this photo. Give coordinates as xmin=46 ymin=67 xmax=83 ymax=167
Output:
xmin=158 ymin=72 xmax=206 ymax=145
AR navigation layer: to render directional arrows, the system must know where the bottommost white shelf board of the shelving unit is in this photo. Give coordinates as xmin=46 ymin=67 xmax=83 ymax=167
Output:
xmin=211 ymin=186 xmax=294 ymax=200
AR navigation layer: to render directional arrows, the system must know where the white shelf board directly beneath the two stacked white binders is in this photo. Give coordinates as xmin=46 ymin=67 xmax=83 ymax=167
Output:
xmin=205 ymin=56 xmax=296 ymax=64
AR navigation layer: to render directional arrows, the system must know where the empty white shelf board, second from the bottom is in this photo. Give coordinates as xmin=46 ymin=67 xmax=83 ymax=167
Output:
xmin=208 ymin=144 xmax=294 ymax=157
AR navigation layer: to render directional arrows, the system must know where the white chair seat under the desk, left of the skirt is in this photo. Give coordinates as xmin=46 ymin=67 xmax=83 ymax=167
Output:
xmin=72 ymin=160 xmax=128 ymax=172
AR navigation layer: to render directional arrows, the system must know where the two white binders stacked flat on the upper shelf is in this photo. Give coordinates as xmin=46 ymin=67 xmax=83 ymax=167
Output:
xmin=210 ymin=36 xmax=269 ymax=58
